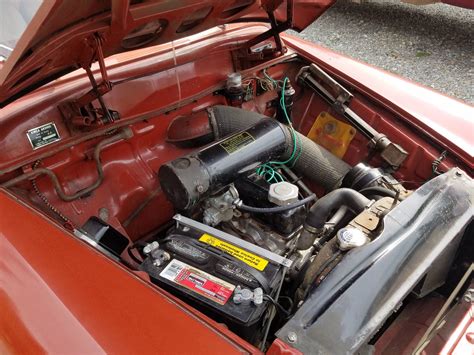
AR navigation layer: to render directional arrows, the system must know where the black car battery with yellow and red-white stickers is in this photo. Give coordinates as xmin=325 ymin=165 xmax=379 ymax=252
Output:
xmin=141 ymin=226 xmax=281 ymax=329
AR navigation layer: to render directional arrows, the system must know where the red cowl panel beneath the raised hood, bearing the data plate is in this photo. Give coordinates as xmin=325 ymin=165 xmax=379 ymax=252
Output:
xmin=0 ymin=25 xmax=267 ymax=174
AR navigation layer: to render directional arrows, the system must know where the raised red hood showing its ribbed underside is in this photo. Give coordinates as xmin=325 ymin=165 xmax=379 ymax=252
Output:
xmin=0 ymin=0 xmax=334 ymax=107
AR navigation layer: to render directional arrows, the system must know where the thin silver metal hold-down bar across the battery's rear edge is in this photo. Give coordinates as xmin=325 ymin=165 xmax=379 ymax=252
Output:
xmin=173 ymin=214 xmax=293 ymax=267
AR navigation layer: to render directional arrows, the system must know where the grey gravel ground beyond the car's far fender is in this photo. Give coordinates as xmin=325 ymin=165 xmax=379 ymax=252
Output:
xmin=290 ymin=0 xmax=474 ymax=104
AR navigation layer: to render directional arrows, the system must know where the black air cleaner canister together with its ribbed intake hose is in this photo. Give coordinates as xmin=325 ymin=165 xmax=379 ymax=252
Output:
xmin=159 ymin=106 xmax=351 ymax=210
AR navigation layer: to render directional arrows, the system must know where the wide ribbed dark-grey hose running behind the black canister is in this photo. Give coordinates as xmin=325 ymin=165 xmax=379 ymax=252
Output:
xmin=209 ymin=105 xmax=351 ymax=191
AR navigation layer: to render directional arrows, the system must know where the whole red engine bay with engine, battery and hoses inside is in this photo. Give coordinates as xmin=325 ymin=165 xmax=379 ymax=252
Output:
xmin=0 ymin=56 xmax=473 ymax=350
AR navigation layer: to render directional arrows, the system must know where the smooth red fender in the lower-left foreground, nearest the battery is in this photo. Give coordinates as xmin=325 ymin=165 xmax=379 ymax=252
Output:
xmin=0 ymin=191 xmax=258 ymax=354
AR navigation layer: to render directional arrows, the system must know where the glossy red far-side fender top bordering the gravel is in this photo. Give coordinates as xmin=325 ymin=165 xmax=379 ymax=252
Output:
xmin=284 ymin=34 xmax=474 ymax=169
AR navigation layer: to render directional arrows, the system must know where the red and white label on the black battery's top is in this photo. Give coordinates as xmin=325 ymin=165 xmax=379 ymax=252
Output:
xmin=160 ymin=259 xmax=235 ymax=305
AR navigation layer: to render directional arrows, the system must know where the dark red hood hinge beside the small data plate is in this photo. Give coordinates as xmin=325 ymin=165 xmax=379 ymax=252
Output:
xmin=58 ymin=33 xmax=120 ymax=133
